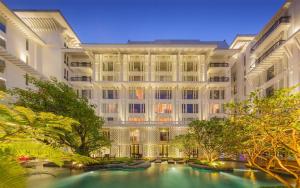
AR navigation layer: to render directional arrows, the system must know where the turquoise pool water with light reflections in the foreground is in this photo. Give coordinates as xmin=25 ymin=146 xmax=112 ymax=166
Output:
xmin=33 ymin=164 xmax=292 ymax=188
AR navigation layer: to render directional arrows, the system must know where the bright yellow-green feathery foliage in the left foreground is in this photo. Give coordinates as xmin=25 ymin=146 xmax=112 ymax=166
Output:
xmin=0 ymin=92 xmax=94 ymax=188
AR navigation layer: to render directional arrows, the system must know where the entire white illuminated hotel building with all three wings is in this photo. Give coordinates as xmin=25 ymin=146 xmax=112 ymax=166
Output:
xmin=0 ymin=1 xmax=300 ymax=157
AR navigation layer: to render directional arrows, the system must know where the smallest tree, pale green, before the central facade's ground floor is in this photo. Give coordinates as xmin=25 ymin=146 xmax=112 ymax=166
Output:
xmin=171 ymin=133 xmax=197 ymax=158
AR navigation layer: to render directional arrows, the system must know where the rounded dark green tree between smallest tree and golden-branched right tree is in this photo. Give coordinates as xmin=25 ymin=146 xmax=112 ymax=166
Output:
xmin=189 ymin=119 xmax=236 ymax=162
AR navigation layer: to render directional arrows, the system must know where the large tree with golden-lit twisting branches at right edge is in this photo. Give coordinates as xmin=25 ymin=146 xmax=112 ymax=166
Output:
xmin=227 ymin=87 xmax=300 ymax=187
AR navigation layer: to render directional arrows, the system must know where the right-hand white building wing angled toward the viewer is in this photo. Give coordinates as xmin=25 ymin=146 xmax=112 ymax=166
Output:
xmin=233 ymin=1 xmax=300 ymax=99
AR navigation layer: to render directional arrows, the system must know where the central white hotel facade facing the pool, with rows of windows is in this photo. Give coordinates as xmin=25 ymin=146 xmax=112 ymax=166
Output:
xmin=82 ymin=40 xmax=238 ymax=157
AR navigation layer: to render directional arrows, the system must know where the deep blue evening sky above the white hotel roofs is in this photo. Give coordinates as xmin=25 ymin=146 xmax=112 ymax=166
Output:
xmin=4 ymin=0 xmax=284 ymax=43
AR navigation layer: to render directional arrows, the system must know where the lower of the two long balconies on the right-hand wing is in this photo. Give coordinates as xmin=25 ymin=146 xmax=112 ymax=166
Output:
xmin=247 ymin=40 xmax=285 ymax=76
